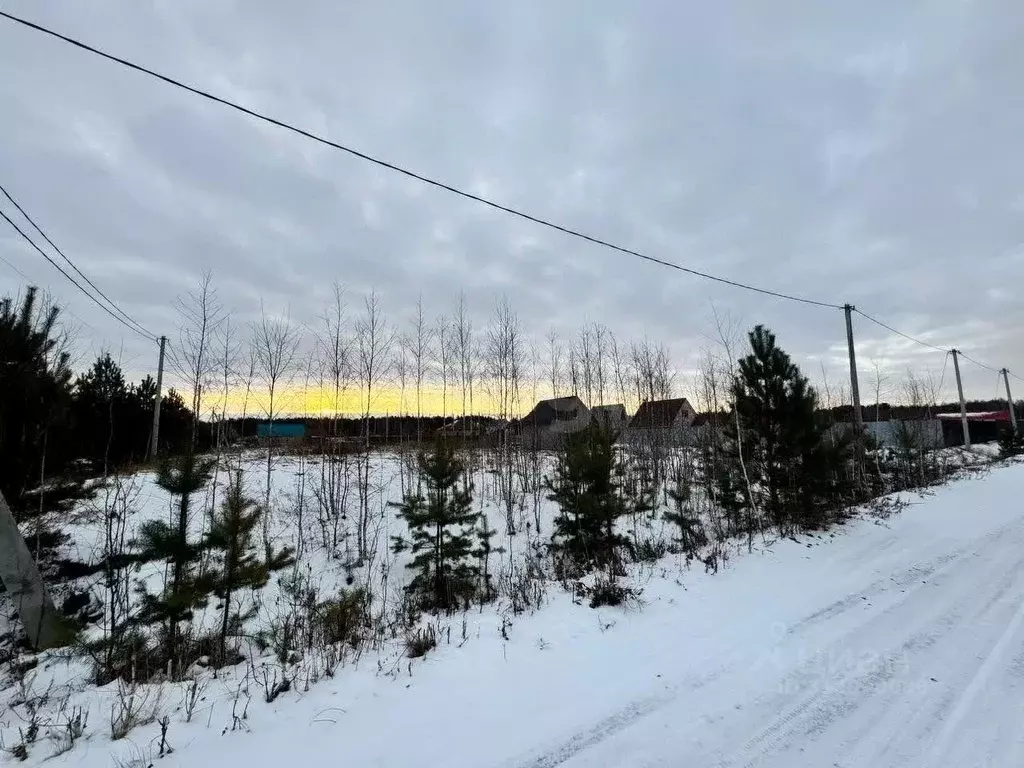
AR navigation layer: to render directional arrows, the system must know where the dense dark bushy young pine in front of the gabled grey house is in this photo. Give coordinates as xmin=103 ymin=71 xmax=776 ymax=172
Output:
xmin=545 ymin=427 xmax=631 ymax=579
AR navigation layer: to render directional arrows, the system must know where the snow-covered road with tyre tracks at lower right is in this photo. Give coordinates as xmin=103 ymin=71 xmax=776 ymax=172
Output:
xmin=495 ymin=468 xmax=1024 ymax=768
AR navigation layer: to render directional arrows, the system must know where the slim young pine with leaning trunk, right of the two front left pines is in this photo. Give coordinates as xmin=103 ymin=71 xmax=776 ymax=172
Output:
xmin=206 ymin=470 xmax=294 ymax=659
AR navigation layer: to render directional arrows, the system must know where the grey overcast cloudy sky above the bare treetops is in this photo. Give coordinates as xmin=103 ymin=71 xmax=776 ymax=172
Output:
xmin=0 ymin=0 xmax=1024 ymax=415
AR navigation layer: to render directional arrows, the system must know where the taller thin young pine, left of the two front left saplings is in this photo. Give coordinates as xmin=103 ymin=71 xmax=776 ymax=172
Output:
xmin=139 ymin=451 xmax=213 ymax=676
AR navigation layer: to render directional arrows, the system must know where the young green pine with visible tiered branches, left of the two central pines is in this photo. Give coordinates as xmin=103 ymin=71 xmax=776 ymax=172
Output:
xmin=393 ymin=440 xmax=489 ymax=610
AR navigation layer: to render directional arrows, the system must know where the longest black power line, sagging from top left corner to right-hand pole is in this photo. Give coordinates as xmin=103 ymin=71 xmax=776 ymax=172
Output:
xmin=0 ymin=10 xmax=843 ymax=309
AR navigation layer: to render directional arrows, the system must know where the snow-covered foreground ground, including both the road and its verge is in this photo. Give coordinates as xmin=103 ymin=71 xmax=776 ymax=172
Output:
xmin=3 ymin=448 xmax=1024 ymax=768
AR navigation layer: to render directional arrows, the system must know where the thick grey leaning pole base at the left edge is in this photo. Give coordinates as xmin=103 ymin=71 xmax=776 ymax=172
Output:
xmin=0 ymin=494 xmax=61 ymax=650
